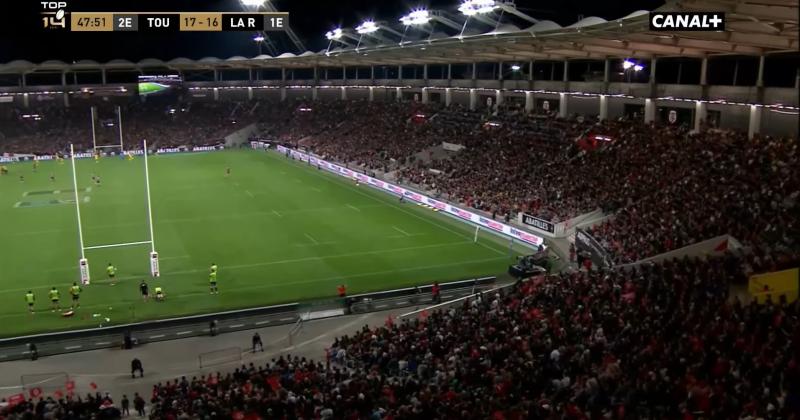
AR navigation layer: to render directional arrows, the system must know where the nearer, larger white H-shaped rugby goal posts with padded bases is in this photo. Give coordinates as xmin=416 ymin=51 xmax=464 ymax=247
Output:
xmin=69 ymin=140 xmax=161 ymax=285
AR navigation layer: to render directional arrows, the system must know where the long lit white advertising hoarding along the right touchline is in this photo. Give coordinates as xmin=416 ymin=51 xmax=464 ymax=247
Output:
xmin=277 ymin=145 xmax=544 ymax=247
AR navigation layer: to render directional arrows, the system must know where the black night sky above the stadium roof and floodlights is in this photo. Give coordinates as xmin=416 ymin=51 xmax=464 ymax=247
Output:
xmin=0 ymin=0 xmax=663 ymax=63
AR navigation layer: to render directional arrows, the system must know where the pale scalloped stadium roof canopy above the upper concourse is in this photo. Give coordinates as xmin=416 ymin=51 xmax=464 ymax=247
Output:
xmin=0 ymin=0 xmax=800 ymax=73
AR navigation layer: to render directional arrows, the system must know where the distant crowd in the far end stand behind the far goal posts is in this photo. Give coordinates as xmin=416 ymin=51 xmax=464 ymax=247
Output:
xmin=0 ymin=101 xmax=259 ymax=155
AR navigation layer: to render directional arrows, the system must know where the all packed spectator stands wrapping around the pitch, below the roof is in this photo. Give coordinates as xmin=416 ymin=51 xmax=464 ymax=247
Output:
xmin=0 ymin=2 xmax=800 ymax=420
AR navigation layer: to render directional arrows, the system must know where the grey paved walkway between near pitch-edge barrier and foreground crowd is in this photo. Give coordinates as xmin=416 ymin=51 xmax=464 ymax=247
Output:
xmin=0 ymin=307 xmax=413 ymax=417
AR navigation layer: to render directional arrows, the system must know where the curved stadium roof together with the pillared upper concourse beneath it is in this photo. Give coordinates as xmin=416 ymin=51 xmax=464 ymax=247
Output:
xmin=0 ymin=0 xmax=800 ymax=136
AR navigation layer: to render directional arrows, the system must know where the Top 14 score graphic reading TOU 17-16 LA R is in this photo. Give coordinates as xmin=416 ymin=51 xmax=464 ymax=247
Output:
xmin=40 ymin=1 xmax=289 ymax=32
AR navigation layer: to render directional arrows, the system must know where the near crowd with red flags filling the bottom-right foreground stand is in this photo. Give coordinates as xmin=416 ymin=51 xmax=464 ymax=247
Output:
xmin=5 ymin=254 xmax=788 ymax=420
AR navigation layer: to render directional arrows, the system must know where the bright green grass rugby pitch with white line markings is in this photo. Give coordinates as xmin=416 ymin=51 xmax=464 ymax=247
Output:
xmin=0 ymin=150 xmax=522 ymax=337
